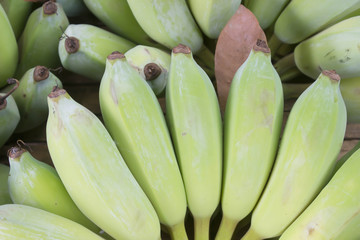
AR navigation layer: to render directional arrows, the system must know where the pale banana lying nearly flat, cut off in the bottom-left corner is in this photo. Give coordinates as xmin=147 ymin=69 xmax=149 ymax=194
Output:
xmin=0 ymin=204 xmax=103 ymax=240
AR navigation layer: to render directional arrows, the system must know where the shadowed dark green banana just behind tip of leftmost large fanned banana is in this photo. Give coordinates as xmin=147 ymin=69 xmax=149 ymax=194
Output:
xmin=5 ymin=66 xmax=62 ymax=133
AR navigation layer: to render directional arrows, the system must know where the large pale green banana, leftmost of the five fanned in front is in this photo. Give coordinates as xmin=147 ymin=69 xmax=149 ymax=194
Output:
xmin=46 ymin=89 xmax=160 ymax=240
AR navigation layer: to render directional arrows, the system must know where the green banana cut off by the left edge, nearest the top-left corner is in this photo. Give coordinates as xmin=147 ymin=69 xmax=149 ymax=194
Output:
xmin=0 ymin=5 xmax=18 ymax=88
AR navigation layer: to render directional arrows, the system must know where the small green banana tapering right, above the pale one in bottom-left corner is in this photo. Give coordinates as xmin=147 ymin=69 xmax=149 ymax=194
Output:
xmin=8 ymin=146 xmax=100 ymax=233
